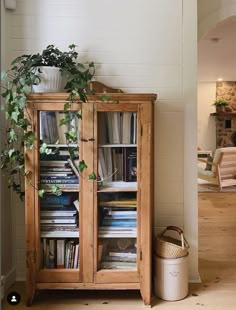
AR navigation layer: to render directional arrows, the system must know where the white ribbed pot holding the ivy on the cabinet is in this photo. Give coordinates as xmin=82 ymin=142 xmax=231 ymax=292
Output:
xmin=32 ymin=66 xmax=63 ymax=93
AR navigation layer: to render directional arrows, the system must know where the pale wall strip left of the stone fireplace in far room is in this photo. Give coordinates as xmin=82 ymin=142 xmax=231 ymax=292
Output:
xmin=197 ymin=82 xmax=216 ymax=151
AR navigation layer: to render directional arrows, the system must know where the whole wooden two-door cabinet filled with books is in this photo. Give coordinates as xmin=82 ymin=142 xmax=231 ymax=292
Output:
xmin=25 ymin=88 xmax=156 ymax=305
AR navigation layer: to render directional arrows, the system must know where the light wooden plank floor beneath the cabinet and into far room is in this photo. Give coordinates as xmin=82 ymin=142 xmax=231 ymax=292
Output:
xmin=2 ymin=193 xmax=236 ymax=310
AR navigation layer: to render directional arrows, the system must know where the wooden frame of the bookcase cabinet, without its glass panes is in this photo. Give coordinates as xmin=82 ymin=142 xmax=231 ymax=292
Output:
xmin=25 ymin=93 xmax=156 ymax=305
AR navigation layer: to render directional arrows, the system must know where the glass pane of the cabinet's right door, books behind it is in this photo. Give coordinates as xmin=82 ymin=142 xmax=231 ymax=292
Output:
xmin=95 ymin=111 xmax=139 ymax=282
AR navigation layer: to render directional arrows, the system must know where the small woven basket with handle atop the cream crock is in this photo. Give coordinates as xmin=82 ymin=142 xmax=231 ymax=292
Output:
xmin=155 ymin=226 xmax=189 ymax=258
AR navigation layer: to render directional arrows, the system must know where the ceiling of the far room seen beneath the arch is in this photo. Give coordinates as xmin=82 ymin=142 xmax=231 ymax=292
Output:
xmin=198 ymin=16 xmax=236 ymax=82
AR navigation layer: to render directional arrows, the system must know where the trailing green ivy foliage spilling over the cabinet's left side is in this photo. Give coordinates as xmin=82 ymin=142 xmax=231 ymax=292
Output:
xmin=1 ymin=44 xmax=96 ymax=199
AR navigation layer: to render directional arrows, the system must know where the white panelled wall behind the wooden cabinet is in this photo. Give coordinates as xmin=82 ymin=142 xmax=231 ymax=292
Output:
xmin=3 ymin=0 xmax=198 ymax=281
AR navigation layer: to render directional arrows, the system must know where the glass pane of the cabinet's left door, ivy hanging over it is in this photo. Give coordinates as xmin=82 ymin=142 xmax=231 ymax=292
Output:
xmin=39 ymin=111 xmax=79 ymax=269
